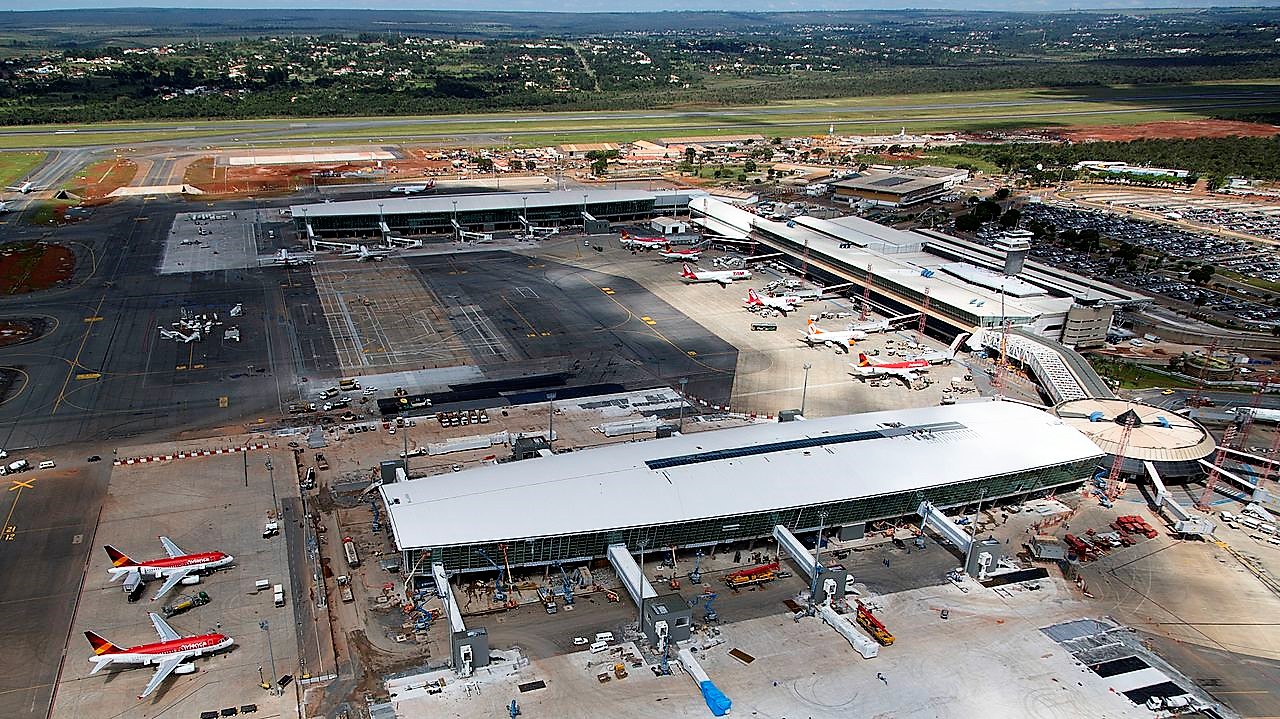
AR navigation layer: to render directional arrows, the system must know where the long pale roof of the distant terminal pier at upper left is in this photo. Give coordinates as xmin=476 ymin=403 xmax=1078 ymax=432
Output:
xmin=289 ymin=189 xmax=655 ymax=217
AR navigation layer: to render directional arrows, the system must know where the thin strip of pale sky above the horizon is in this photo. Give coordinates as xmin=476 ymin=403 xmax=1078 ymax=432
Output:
xmin=0 ymin=0 xmax=1280 ymax=13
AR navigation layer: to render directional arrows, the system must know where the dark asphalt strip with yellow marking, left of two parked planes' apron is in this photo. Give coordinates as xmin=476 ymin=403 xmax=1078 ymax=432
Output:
xmin=0 ymin=461 xmax=108 ymax=719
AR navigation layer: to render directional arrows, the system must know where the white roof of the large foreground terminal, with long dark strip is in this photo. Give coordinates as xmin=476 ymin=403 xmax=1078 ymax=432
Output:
xmin=380 ymin=402 xmax=1101 ymax=549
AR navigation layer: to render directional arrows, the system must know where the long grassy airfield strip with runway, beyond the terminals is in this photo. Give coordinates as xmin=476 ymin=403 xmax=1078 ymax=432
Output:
xmin=0 ymin=79 xmax=1280 ymax=148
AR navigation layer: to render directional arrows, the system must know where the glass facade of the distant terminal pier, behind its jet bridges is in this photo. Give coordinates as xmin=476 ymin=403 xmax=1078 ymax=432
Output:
xmin=293 ymin=193 xmax=654 ymax=237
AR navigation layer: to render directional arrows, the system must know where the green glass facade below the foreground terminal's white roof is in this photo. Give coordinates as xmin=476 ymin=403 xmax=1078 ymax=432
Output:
xmin=404 ymin=455 xmax=1101 ymax=573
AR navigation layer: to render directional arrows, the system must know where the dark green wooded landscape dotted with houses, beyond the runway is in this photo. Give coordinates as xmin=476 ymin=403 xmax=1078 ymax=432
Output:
xmin=0 ymin=9 xmax=1280 ymax=124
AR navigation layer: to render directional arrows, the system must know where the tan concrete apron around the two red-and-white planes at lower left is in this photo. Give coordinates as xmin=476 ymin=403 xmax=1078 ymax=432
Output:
xmin=52 ymin=440 xmax=296 ymax=719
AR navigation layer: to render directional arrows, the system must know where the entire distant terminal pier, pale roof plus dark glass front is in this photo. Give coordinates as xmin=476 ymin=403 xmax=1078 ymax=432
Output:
xmin=289 ymin=189 xmax=705 ymax=237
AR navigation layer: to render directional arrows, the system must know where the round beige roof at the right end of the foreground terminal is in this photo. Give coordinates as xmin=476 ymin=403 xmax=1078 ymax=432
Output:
xmin=1053 ymin=399 xmax=1217 ymax=462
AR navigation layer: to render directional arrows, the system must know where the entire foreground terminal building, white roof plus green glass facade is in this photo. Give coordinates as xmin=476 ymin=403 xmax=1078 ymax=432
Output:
xmin=380 ymin=402 xmax=1102 ymax=572
